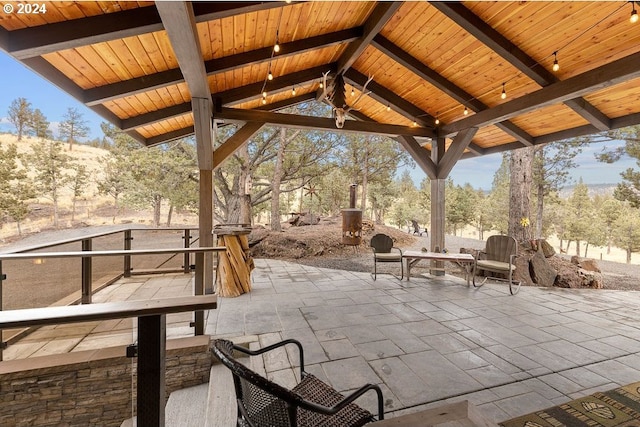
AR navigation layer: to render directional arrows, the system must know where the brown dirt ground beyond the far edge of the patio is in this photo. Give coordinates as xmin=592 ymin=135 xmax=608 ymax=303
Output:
xmin=250 ymin=217 xmax=640 ymax=292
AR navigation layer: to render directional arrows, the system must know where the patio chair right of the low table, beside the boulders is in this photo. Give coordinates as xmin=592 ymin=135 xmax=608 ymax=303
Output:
xmin=472 ymin=236 xmax=522 ymax=295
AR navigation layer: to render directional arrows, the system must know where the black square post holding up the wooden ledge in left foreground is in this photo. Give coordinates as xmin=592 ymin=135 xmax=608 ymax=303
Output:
xmin=136 ymin=314 xmax=167 ymax=427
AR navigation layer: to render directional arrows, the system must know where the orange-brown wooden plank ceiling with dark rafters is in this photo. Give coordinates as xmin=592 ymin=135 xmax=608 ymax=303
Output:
xmin=0 ymin=1 xmax=640 ymax=164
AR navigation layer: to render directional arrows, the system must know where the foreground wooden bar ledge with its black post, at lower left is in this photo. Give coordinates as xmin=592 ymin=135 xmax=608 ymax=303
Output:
xmin=0 ymin=295 xmax=217 ymax=426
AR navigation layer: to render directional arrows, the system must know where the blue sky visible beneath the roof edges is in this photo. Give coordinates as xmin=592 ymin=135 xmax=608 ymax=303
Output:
xmin=0 ymin=51 xmax=637 ymax=190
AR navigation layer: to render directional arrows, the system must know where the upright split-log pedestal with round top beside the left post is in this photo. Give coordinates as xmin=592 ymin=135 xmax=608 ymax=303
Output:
xmin=215 ymin=227 xmax=254 ymax=297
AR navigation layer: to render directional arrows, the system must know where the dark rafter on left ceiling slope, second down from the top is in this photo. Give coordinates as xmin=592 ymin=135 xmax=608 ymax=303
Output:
xmin=83 ymin=27 xmax=362 ymax=105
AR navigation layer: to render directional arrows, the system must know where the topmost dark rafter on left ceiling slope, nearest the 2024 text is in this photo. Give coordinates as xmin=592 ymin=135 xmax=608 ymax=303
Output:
xmin=5 ymin=2 xmax=282 ymax=59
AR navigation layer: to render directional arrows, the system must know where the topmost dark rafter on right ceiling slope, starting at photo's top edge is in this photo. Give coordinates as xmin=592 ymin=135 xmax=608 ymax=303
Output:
xmin=431 ymin=2 xmax=611 ymax=131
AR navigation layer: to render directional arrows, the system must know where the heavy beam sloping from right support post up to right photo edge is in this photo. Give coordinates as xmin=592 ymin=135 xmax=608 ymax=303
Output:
xmin=441 ymin=53 xmax=640 ymax=135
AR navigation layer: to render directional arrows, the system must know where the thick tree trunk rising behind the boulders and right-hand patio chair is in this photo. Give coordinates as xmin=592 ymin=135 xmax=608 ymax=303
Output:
xmin=508 ymin=147 xmax=534 ymax=241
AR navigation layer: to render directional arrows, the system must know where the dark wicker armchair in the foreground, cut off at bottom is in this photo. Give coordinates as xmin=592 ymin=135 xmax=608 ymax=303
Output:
xmin=212 ymin=339 xmax=384 ymax=427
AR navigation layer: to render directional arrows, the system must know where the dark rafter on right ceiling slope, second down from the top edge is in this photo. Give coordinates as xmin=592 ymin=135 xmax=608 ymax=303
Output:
xmin=372 ymin=34 xmax=533 ymax=146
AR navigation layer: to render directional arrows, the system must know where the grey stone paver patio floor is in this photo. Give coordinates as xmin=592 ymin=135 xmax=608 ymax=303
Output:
xmin=5 ymin=259 xmax=640 ymax=422
